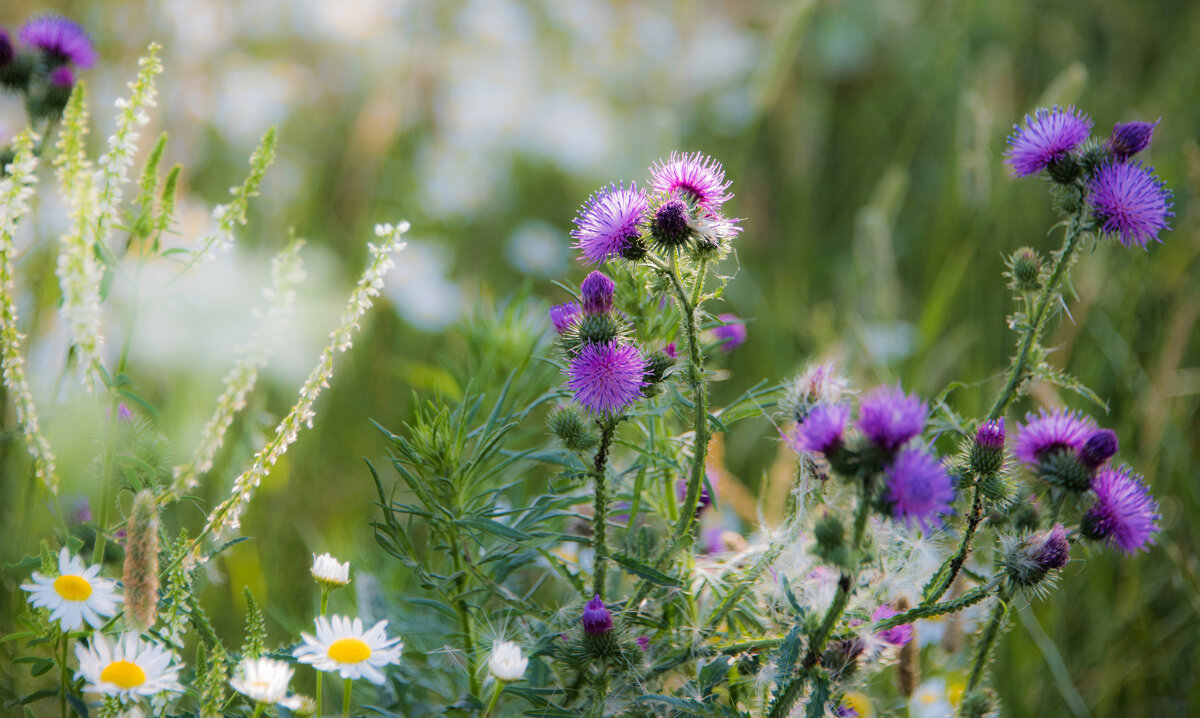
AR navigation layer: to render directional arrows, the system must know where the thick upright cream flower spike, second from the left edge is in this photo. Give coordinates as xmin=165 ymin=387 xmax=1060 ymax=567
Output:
xmin=54 ymin=82 xmax=104 ymax=391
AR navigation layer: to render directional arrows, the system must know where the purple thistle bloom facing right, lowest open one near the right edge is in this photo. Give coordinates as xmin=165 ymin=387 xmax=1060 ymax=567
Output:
xmin=1081 ymin=466 xmax=1163 ymax=554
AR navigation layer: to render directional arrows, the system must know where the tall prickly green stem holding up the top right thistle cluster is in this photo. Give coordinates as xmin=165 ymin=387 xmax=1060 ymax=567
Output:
xmin=922 ymin=203 xmax=1087 ymax=605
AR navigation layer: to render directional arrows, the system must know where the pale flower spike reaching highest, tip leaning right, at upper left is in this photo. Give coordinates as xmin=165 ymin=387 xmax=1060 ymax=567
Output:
xmin=92 ymin=42 xmax=162 ymax=262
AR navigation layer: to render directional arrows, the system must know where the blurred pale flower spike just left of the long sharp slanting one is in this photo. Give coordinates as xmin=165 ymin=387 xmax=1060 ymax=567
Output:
xmin=170 ymin=239 xmax=305 ymax=496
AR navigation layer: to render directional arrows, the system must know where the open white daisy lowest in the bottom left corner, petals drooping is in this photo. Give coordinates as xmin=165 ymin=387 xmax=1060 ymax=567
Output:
xmin=76 ymin=633 xmax=184 ymax=702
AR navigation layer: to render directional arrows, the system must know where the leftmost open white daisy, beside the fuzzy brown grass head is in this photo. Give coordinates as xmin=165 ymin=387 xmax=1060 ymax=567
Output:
xmin=20 ymin=546 xmax=121 ymax=630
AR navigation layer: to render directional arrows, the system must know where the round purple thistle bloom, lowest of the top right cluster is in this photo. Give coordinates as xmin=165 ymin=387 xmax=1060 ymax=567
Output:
xmin=1088 ymin=162 xmax=1175 ymax=249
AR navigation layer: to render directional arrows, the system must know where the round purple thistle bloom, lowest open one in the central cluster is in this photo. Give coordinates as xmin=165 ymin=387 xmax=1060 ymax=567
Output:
xmin=566 ymin=341 xmax=646 ymax=415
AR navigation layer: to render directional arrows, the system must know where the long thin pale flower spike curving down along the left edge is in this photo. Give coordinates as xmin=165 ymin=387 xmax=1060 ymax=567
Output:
xmin=0 ymin=130 xmax=59 ymax=493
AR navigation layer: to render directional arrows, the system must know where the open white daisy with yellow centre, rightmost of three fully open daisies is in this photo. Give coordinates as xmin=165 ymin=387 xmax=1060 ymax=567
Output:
xmin=292 ymin=616 xmax=404 ymax=684
